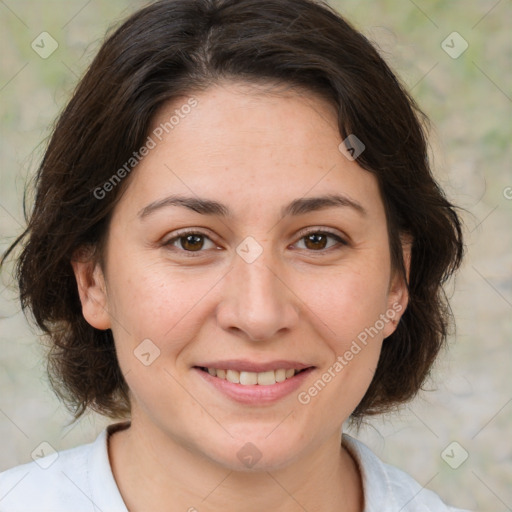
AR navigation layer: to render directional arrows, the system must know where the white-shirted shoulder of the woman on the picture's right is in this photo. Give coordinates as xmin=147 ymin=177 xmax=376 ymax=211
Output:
xmin=343 ymin=434 xmax=469 ymax=512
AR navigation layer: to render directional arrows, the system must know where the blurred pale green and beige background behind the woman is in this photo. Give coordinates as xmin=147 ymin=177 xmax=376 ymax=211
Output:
xmin=0 ymin=0 xmax=512 ymax=512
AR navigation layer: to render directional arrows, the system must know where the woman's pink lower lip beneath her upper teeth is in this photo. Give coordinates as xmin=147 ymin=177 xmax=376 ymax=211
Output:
xmin=193 ymin=368 xmax=314 ymax=405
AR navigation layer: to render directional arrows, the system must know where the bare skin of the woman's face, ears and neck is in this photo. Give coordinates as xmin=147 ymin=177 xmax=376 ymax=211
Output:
xmin=74 ymin=82 xmax=408 ymax=512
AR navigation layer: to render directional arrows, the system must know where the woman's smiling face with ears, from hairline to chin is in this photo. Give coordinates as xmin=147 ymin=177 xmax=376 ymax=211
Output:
xmin=74 ymin=83 xmax=407 ymax=469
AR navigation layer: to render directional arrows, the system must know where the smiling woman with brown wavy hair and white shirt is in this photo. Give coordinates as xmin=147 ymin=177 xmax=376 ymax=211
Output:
xmin=0 ymin=0 xmax=472 ymax=512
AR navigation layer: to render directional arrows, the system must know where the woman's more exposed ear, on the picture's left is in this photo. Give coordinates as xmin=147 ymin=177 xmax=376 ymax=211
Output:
xmin=71 ymin=248 xmax=111 ymax=330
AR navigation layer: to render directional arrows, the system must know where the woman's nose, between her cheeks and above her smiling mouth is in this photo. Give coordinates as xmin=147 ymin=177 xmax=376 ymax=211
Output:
xmin=216 ymin=246 xmax=300 ymax=341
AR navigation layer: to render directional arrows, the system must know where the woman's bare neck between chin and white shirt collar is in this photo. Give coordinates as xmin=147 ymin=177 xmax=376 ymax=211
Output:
xmin=109 ymin=418 xmax=363 ymax=512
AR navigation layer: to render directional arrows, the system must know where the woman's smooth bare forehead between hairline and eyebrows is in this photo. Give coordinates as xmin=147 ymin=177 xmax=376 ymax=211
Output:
xmin=115 ymin=83 xmax=382 ymax=222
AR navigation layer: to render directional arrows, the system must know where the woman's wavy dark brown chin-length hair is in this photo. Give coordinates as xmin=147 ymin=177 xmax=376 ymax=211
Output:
xmin=2 ymin=0 xmax=463 ymax=419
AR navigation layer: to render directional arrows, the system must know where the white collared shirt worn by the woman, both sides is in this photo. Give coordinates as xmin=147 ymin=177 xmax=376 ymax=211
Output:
xmin=0 ymin=423 xmax=469 ymax=512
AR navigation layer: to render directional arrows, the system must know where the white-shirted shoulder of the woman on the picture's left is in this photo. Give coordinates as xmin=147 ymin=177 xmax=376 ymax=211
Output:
xmin=0 ymin=429 xmax=126 ymax=512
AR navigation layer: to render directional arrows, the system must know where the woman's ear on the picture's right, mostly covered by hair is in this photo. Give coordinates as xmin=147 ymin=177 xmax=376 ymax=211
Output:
xmin=384 ymin=235 xmax=413 ymax=338
